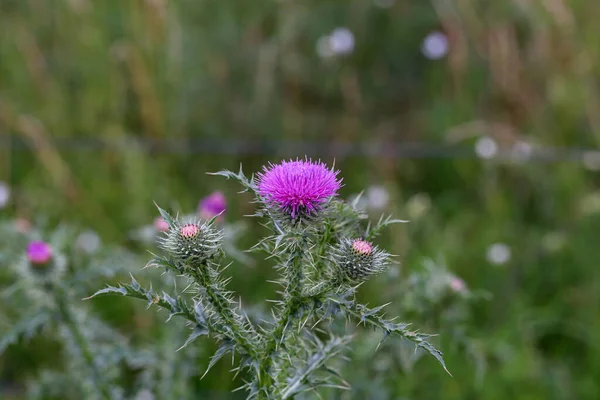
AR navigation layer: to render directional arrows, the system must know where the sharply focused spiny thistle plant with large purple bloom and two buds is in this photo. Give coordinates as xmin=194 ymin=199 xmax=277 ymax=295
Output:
xmin=86 ymin=159 xmax=446 ymax=399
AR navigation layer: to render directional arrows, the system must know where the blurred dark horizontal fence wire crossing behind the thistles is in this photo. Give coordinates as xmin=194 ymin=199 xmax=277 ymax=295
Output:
xmin=0 ymin=135 xmax=600 ymax=166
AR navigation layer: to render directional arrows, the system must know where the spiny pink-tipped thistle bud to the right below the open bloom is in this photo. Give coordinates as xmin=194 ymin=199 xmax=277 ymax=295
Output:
xmin=333 ymin=239 xmax=391 ymax=283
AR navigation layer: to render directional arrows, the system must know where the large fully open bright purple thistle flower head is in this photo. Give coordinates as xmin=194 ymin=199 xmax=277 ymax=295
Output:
xmin=258 ymin=159 xmax=342 ymax=218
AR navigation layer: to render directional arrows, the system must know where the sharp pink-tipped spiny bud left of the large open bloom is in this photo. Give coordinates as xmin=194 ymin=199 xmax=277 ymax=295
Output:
xmin=159 ymin=222 xmax=223 ymax=263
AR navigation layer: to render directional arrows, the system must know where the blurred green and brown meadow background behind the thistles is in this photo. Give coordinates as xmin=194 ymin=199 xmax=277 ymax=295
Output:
xmin=0 ymin=0 xmax=600 ymax=400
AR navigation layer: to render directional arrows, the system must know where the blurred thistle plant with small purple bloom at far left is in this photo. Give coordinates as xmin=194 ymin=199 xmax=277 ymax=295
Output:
xmin=0 ymin=223 xmax=153 ymax=399
